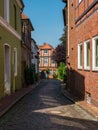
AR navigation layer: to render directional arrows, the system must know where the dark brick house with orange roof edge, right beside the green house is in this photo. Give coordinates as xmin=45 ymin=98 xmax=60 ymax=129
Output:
xmin=21 ymin=13 xmax=34 ymax=86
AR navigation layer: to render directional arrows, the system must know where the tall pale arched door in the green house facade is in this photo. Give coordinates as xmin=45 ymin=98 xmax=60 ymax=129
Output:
xmin=4 ymin=45 xmax=11 ymax=94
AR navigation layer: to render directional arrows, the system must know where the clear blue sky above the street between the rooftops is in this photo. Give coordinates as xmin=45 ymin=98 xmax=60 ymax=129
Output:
xmin=23 ymin=0 xmax=64 ymax=47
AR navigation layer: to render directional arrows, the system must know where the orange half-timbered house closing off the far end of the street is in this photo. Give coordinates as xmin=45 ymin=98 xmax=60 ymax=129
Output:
xmin=39 ymin=43 xmax=57 ymax=78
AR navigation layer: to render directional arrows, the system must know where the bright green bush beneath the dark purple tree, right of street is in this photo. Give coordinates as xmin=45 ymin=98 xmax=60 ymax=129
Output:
xmin=58 ymin=62 xmax=67 ymax=82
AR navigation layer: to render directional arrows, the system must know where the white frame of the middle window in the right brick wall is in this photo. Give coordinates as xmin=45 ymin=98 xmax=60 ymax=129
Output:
xmin=84 ymin=40 xmax=90 ymax=70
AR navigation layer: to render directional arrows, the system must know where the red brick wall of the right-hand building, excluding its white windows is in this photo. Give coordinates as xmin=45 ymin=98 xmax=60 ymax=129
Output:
xmin=67 ymin=0 xmax=98 ymax=106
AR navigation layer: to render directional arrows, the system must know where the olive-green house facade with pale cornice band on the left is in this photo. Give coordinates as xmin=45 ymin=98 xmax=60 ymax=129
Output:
xmin=0 ymin=0 xmax=24 ymax=98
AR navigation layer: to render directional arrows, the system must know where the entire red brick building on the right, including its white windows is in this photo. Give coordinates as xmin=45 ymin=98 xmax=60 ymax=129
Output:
xmin=63 ymin=0 xmax=98 ymax=106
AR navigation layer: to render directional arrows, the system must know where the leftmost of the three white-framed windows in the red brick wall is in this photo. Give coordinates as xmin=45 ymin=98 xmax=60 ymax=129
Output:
xmin=78 ymin=43 xmax=82 ymax=69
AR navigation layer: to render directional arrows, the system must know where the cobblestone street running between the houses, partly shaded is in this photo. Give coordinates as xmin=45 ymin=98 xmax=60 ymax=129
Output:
xmin=0 ymin=80 xmax=98 ymax=130
